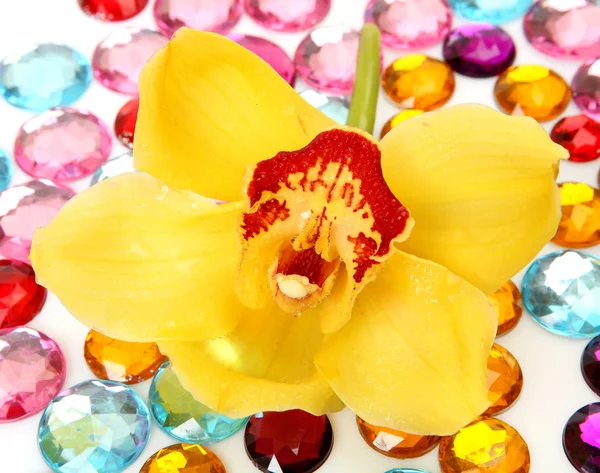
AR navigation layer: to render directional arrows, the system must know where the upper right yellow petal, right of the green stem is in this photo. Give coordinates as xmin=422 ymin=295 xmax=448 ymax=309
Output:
xmin=380 ymin=104 xmax=568 ymax=294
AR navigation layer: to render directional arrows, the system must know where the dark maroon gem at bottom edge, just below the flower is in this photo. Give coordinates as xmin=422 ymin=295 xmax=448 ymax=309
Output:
xmin=244 ymin=409 xmax=333 ymax=473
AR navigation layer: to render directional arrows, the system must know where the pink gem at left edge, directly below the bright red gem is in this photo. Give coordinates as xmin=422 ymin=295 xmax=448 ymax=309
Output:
xmin=0 ymin=327 xmax=67 ymax=423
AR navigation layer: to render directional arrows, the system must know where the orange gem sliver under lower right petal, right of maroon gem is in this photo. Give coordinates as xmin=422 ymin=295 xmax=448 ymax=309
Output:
xmin=356 ymin=416 xmax=441 ymax=459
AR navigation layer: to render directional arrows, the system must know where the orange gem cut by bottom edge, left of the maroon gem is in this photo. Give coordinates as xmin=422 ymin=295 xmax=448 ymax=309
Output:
xmin=140 ymin=443 xmax=226 ymax=473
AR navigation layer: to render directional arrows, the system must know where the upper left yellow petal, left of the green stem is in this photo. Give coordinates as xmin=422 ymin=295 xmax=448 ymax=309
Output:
xmin=134 ymin=28 xmax=335 ymax=200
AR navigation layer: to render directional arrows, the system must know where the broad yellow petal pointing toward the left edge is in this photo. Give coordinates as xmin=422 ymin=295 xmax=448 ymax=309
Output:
xmin=31 ymin=173 xmax=248 ymax=341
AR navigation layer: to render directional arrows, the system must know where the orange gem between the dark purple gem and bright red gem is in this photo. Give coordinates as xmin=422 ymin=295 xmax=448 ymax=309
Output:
xmin=494 ymin=65 xmax=571 ymax=122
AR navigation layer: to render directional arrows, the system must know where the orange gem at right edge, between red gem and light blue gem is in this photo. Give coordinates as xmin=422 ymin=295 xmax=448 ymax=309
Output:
xmin=552 ymin=182 xmax=600 ymax=248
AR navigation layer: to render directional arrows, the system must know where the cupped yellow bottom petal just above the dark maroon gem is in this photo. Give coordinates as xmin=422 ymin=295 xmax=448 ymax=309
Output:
xmin=159 ymin=303 xmax=343 ymax=418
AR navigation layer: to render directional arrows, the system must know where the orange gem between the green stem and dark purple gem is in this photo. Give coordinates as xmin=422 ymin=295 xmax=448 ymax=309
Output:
xmin=381 ymin=54 xmax=455 ymax=112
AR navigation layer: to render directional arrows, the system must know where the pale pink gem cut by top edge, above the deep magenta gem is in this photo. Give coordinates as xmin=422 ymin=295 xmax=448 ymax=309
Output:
xmin=244 ymin=0 xmax=331 ymax=31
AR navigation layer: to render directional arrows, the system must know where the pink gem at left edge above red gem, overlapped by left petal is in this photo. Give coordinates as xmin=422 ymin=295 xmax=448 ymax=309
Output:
xmin=0 ymin=179 xmax=75 ymax=263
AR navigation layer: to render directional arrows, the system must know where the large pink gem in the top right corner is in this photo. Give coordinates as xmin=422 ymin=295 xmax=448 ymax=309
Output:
xmin=523 ymin=0 xmax=600 ymax=60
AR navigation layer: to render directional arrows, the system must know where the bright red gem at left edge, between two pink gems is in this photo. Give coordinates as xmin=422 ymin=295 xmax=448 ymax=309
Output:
xmin=0 ymin=260 xmax=46 ymax=329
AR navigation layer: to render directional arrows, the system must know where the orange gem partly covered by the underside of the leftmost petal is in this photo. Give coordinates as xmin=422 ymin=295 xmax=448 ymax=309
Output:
xmin=83 ymin=330 xmax=167 ymax=384
